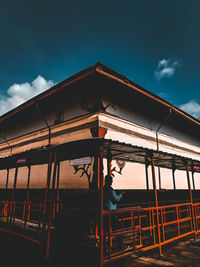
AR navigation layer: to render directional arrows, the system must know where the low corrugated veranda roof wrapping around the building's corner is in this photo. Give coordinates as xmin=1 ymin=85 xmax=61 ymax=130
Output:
xmin=0 ymin=137 xmax=200 ymax=172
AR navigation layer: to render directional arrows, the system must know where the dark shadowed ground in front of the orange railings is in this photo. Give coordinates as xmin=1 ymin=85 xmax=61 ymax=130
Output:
xmin=0 ymin=233 xmax=200 ymax=267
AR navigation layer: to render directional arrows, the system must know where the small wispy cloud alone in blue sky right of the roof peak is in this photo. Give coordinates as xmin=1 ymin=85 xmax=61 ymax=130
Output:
xmin=154 ymin=58 xmax=179 ymax=81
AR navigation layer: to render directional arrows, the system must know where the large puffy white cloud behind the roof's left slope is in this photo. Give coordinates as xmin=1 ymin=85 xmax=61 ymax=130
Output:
xmin=0 ymin=75 xmax=54 ymax=115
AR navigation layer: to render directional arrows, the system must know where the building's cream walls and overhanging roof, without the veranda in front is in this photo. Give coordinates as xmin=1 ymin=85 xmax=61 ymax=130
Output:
xmin=0 ymin=63 xmax=200 ymax=193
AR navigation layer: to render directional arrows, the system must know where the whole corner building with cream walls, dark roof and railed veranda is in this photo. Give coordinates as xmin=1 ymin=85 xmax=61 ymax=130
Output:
xmin=0 ymin=63 xmax=200 ymax=267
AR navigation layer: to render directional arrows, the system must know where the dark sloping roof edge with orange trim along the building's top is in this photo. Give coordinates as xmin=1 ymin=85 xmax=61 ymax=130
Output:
xmin=0 ymin=62 xmax=200 ymax=129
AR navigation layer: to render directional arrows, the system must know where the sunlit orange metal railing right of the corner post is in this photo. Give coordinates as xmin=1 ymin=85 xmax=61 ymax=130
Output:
xmin=103 ymin=203 xmax=197 ymax=263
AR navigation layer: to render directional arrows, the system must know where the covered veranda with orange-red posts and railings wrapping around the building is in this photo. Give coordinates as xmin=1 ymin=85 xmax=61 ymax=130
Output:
xmin=0 ymin=138 xmax=200 ymax=266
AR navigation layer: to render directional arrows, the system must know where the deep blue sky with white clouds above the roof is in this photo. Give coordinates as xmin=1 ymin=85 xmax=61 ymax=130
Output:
xmin=0 ymin=0 xmax=200 ymax=119
